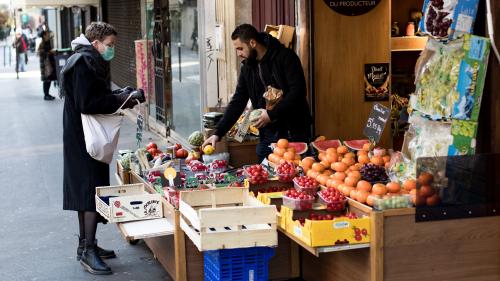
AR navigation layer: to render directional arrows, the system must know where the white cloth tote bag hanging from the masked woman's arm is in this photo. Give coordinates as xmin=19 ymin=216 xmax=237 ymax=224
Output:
xmin=81 ymin=93 xmax=132 ymax=164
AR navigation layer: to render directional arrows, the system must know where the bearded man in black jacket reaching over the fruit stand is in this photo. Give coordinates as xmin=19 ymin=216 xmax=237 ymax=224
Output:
xmin=203 ymin=24 xmax=312 ymax=162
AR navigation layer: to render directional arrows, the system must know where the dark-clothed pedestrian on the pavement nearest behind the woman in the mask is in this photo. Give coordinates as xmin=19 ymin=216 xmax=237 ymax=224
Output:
xmin=38 ymin=30 xmax=57 ymax=100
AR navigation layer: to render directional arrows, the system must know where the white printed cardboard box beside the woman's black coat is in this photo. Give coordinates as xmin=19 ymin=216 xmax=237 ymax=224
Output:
xmin=95 ymin=183 xmax=163 ymax=222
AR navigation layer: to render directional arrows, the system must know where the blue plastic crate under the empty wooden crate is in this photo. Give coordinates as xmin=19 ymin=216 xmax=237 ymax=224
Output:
xmin=204 ymin=247 xmax=274 ymax=281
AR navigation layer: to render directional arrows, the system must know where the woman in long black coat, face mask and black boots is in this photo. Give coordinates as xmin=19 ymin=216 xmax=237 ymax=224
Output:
xmin=61 ymin=22 xmax=145 ymax=274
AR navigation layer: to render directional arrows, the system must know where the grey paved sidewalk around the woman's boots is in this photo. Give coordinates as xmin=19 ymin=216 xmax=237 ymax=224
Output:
xmin=0 ymin=52 xmax=173 ymax=281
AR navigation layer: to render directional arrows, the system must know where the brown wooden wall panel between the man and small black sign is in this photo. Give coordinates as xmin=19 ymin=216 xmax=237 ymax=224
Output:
xmin=311 ymin=0 xmax=391 ymax=147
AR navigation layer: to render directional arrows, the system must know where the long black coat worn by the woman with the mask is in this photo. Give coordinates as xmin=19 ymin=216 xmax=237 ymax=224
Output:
xmin=61 ymin=45 xmax=121 ymax=211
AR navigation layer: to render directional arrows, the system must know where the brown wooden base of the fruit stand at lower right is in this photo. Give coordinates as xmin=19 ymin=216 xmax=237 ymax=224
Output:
xmin=288 ymin=197 xmax=500 ymax=281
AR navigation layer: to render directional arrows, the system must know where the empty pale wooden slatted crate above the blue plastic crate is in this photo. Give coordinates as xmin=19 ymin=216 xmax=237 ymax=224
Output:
xmin=179 ymin=188 xmax=278 ymax=251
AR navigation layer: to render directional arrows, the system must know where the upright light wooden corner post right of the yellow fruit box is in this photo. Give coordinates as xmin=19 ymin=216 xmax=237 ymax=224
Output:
xmin=370 ymin=212 xmax=384 ymax=281
